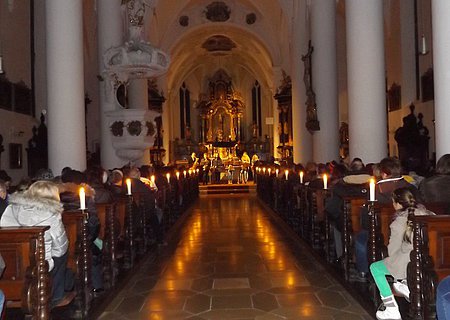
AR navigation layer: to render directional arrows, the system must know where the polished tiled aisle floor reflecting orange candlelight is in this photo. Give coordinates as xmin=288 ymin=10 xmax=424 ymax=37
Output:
xmin=101 ymin=194 xmax=372 ymax=320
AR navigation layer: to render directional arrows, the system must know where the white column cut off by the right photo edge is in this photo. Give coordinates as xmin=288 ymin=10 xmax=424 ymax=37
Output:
xmin=431 ymin=0 xmax=450 ymax=159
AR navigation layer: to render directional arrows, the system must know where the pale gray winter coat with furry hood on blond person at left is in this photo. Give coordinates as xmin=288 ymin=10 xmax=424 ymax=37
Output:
xmin=0 ymin=193 xmax=69 ymax=270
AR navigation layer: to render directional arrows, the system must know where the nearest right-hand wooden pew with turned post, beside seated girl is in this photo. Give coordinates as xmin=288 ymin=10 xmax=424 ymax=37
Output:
xmin=407 ymin=212 xmax=450 ymax=319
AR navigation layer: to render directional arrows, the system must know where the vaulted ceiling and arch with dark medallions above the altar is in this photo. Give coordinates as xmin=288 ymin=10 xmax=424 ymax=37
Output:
xmin=147 ymin=0 xmax=297 ymax=88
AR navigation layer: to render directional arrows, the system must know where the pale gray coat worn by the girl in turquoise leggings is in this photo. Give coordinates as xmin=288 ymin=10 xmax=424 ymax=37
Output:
xmin=384 ymin=205 xmax=434 ymax=279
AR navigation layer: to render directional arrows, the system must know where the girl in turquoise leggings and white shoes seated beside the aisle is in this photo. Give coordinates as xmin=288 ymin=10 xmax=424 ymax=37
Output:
xmin=370 ymin=188 xmax=434 ymax=320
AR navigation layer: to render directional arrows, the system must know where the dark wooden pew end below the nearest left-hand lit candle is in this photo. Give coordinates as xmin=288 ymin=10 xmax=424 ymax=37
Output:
xmin=62 ymin=210 xmax=92 ymax=317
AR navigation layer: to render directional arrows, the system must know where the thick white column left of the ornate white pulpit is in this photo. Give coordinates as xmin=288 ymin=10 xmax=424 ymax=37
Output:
xmin=46 ymin=0 xmax=86 ymax=175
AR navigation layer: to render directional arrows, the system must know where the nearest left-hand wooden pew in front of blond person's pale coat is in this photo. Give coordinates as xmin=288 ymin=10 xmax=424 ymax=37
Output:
xmin=0 ymin=227 xmax=51 ymax=320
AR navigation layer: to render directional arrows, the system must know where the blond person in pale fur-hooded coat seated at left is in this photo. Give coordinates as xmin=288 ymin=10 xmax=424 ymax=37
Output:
xmin=0 ymin=181 xmax=69 ymax=306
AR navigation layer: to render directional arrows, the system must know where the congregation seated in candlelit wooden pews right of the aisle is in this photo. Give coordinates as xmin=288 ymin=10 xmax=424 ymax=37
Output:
xmin=256 ymin=155 xmax=450 ymax=319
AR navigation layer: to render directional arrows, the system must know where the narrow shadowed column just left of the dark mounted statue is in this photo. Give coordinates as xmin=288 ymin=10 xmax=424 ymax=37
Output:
xmin=291 ymin=0 xmax=312 ymax=164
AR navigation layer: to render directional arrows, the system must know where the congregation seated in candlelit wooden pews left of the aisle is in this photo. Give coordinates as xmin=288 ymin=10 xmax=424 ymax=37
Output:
xmin=0 ymin=167 xmax=198 ymax=319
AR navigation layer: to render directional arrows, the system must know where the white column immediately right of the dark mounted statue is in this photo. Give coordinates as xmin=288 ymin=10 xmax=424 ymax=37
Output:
xmin=311 ymin=0 xmax=339 ymax=163
